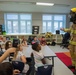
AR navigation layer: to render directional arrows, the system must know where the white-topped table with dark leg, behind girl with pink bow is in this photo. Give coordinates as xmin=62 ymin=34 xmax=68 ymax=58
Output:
xmin=23 ymin=45 xmax=56 ymax=66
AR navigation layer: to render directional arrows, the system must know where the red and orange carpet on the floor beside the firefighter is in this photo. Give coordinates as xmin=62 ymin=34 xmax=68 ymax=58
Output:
xmin=56 ymin=52 xmax=74 ymax=71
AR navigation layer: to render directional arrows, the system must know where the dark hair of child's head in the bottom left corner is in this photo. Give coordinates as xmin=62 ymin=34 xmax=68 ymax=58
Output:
xmin=0 ymin=62 xmax=13 ymax=75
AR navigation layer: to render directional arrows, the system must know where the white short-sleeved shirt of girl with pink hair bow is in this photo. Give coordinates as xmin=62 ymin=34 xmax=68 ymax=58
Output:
xmin=33 ymin=51 xmax=44 ymax=68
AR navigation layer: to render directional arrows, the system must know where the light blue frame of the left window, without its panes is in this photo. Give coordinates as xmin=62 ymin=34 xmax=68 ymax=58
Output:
xmin=4 ymin=13 xmax=32 ymax=35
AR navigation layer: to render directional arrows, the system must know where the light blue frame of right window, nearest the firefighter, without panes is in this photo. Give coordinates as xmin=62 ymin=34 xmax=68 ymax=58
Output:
xmin=42 ymin=14 xmax=66 ymax=34
